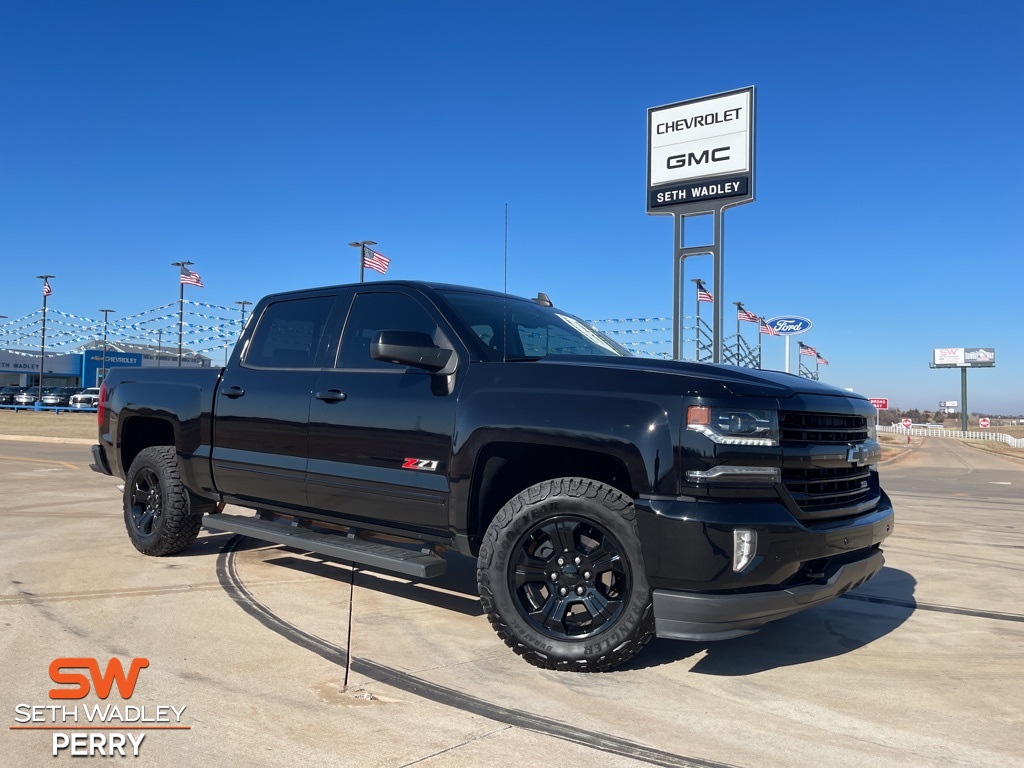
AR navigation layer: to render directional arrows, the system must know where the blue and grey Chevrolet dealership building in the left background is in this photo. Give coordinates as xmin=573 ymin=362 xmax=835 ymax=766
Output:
xmin=0 ymin=342 xmax=212 ymax=387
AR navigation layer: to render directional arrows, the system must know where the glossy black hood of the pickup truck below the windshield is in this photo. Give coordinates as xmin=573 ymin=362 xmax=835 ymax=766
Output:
xmin=525 ymin=355 xmax=864 ymax=399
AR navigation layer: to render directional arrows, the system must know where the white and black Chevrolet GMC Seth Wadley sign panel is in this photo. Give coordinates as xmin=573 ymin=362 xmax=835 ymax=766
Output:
xmin=647 ymin=86 xmax=754 ymax=213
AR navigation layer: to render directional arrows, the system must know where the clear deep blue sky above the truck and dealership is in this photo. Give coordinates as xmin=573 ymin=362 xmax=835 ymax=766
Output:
xmin=0 ymin=0 xmax=1024 ymax=413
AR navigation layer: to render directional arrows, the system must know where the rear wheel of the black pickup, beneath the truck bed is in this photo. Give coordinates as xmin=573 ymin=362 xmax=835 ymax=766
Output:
xmin=124 ymin=445 xmax=216 ymax=557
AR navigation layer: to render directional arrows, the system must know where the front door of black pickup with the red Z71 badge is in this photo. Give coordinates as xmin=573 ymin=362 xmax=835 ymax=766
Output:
xmin=307 ymin=287 xmax=458 ymax=530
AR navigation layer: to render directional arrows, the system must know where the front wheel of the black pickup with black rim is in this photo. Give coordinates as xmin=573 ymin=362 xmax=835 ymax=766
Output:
xmin=477 ymin=477 xmax=654 ymax=672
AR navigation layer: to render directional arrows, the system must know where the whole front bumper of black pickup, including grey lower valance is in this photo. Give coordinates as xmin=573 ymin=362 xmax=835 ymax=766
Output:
xmin=636 ymin=492 xmax=894 ymax=640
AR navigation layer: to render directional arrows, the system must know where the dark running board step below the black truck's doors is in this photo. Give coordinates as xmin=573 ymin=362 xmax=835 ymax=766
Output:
xmin=203 ymin=513 xmax=447 ymax=579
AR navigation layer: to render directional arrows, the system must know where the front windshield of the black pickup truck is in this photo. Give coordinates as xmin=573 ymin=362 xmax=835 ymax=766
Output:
xmin=441 ymin=291 xmax=630 ymax=359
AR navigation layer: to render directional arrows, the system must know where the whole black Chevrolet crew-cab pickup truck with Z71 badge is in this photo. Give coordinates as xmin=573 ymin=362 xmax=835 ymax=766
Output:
xmin=93 ymin=282 xmax=893 ymax=672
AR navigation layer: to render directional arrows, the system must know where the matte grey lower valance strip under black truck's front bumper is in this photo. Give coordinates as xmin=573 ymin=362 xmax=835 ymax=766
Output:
xmin=654 ymin=549 xmax=885 ymax=640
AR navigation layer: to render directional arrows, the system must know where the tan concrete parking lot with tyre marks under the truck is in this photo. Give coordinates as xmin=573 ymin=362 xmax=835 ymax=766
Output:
xmin=0 ymin=438 xmax=1024 ymax=766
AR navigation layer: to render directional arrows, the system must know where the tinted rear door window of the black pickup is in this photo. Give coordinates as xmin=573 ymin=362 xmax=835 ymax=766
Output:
xmin=245 ymin=296 xmax=334 ymax=368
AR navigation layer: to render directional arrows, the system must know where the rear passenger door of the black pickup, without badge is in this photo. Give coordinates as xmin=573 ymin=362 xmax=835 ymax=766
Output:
xmin=213 ymin=294 xmax=336 ymax=508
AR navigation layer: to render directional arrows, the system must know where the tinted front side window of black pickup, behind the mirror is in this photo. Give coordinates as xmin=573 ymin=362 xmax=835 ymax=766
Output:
xmin=338 ymin=293 xmax=446 ymax=371
